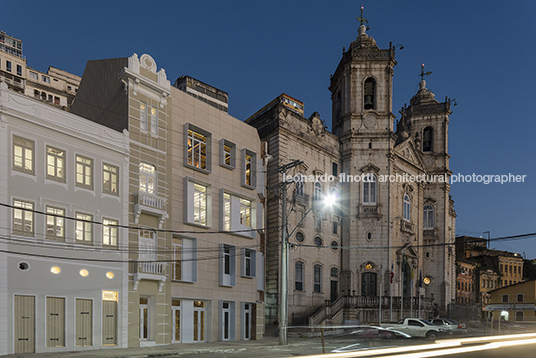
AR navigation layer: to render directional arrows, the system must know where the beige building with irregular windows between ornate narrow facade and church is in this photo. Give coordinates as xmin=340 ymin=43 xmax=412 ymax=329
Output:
xmin=168 ymin=77 xmax=266 ymax=343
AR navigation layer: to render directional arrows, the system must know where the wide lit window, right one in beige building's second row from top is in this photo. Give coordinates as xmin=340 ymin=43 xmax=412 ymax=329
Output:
xmin=220 ymin=189 xmax=256 ymax=238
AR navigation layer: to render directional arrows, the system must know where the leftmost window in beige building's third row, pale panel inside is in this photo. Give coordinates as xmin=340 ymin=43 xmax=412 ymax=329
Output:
xmin=171 ymin=236 xmax=197 ymax=282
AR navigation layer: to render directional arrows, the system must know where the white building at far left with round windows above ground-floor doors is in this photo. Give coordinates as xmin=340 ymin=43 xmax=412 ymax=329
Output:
xmin=0 ymin=82 xmax=129 ymax=354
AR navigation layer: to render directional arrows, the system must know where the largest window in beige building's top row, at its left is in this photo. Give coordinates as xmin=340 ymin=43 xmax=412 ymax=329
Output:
xmin=184 ymin=123 xmax=212 ymax=172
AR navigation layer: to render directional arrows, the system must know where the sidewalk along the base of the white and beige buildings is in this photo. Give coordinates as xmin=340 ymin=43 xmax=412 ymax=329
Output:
xmin=4 ymin=337 xmax=307 ymax=358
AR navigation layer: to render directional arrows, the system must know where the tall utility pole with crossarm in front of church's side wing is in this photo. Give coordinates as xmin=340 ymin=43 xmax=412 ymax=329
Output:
xmin=268 ymin=160 xmax=303 ymax=346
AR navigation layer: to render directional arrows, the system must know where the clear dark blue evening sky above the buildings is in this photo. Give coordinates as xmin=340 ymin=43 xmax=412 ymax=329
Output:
xmin=6 ymin=0 xmax=536 ymax=258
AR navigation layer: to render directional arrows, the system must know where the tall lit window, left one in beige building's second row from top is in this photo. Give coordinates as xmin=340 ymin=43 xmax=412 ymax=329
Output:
xmin=184 ymin=177 xmax=211 ymax=229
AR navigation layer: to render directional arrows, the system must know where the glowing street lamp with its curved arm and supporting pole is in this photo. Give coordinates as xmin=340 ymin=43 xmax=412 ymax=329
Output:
xmin=279 ymin=186 xmax=337 ymax=346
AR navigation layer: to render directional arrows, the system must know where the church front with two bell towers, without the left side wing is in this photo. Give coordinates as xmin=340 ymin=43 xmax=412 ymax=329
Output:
xmin=329 ymin=8 xmax=456 ymax=318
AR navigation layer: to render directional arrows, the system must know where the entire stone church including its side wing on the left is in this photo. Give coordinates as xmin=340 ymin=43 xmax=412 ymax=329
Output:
xmin=246 ymin=25 xmax=456 ymax=325
